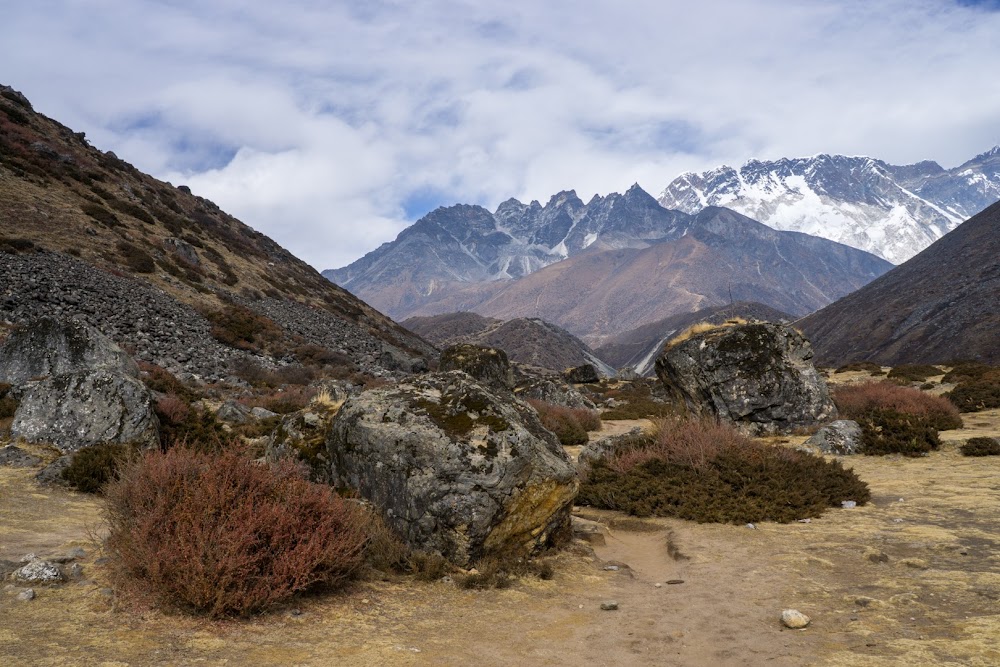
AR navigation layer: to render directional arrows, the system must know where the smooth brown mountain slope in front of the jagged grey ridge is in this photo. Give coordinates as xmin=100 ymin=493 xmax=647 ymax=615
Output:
xmin=394 ymin=208 xmax=892 ymax=347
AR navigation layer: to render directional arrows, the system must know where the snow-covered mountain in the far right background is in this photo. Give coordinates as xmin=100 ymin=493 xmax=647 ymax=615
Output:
xmin=659 ymin=147 xmax=1000 ymax=264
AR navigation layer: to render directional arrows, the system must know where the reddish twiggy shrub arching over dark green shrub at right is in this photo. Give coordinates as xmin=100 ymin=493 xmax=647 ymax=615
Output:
xmin=833 ymin=382 xmax=962 ymax=431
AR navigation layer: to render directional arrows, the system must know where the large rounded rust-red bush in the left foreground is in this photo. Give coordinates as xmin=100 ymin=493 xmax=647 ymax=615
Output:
xmin=105 ymin=447 xmax=366 ymax=617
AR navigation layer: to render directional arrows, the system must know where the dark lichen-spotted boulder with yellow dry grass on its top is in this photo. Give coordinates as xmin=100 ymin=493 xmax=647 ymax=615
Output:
xmin=656 ymin=322 xmax=837 ymax=434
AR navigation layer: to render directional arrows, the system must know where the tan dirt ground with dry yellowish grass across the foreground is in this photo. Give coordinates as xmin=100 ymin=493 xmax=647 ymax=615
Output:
xmin=0 ymin=411 xmax=1000 ymax=667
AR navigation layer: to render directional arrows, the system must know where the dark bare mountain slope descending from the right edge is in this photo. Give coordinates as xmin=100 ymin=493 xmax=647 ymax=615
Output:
xmin=798 ymin=203 xmax=1000 ymax=365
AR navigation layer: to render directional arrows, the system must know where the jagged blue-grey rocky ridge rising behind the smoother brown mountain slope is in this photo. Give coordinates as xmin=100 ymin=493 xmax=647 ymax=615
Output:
xmin=323 ymin=185 xmax=691 ymax=320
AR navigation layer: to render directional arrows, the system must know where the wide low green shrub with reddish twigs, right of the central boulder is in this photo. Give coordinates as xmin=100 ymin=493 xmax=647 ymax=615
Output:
xmin=577 ymin=420 xmax=870 ymax=523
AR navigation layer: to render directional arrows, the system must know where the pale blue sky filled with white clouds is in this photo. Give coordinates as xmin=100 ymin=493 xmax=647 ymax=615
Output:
xmin=0 ymin=0 xmax=1000 ymax=270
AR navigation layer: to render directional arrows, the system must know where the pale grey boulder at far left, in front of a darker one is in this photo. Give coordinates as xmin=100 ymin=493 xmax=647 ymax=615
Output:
xmin=11 ymin=370 xmax=159 ymax=452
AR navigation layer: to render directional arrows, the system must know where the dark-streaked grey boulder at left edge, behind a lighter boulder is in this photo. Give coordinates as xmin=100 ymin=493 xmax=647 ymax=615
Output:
xmin=0 ymin=317 xmax=139 ymax=385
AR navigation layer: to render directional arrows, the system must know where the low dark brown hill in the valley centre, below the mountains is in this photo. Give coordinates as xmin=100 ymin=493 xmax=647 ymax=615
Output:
xmin=402 ymin=313 xmax=615 ymax=377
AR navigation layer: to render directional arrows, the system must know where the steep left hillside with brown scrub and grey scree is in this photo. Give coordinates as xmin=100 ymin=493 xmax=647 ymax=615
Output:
xmin=0 ymin=87 xmax=434 ymax=378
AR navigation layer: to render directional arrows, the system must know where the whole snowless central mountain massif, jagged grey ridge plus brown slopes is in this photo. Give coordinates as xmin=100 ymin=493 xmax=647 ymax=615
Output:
xmin=324 ymin=185 xmax=891 ymax=345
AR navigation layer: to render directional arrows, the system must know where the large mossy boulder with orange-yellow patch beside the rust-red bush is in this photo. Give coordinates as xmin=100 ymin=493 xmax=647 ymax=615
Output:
xmin=327 ymin=371 xmax=578 ymax=566
